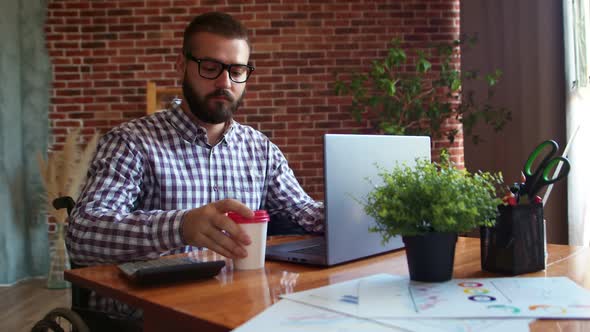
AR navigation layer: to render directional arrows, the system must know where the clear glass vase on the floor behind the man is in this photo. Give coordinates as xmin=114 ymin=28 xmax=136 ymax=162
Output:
xmin=47 ymin=222 xmax=70 ymax=289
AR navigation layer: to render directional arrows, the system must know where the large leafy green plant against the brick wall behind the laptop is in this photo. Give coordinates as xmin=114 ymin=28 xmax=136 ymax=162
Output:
xmin=335 ymin=38 xmax=511 ymax=143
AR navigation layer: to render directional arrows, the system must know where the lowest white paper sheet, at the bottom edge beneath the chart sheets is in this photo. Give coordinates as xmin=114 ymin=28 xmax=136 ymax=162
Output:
xmin=233 ymin=300 xmax=532 ymax=332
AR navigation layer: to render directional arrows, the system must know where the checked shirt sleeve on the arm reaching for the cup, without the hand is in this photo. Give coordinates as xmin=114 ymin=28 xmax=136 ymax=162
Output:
xmin=67 ymin=131 xmax=186 ymax=264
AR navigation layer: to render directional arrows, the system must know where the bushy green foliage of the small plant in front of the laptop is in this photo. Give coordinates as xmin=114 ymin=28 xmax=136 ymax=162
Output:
xmin=361 ymin=152 xmax=502 ymax=242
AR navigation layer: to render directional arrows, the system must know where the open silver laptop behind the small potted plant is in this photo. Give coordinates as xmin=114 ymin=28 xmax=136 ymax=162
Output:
xmin=266 ymin=134 xmax=430 ymax=266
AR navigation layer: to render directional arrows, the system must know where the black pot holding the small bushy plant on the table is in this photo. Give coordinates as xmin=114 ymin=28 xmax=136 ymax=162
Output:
xmin=402 ymin=233 xmax=457 ymax=282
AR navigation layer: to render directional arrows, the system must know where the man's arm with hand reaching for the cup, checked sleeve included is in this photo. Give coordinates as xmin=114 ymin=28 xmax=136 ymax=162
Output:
xmin=67 ymin=132 xmax=253 ymax=264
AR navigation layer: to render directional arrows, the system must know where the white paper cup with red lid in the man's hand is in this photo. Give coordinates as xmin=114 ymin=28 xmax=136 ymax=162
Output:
xmin=227 ymin=210 xmax=270 ymax=270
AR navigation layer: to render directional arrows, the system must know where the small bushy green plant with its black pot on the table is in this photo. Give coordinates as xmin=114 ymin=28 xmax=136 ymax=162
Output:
xmin=361 ymin=151 xmax=502 ymax=282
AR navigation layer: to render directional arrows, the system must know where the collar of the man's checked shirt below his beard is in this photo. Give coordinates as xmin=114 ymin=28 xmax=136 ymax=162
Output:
xmin=167 ymin=103 xmax=239 ymax=145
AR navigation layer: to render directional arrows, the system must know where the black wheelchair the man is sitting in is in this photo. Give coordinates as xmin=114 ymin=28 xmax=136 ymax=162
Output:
xmin=31 ymin=196 xmax=141 ymax=332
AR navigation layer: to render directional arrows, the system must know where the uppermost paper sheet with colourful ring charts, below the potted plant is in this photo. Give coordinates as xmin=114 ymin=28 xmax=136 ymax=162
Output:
xmin=358 ymin=277 xmax=590 ymax=319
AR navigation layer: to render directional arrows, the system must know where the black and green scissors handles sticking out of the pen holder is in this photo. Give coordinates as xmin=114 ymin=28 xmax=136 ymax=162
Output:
xmin=523 ymin=140 xmax=570 ymax=198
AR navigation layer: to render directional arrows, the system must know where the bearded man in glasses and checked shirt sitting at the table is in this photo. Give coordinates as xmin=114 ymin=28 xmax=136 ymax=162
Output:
xmin=67 ymin=13 xmax=323 ymax=322
